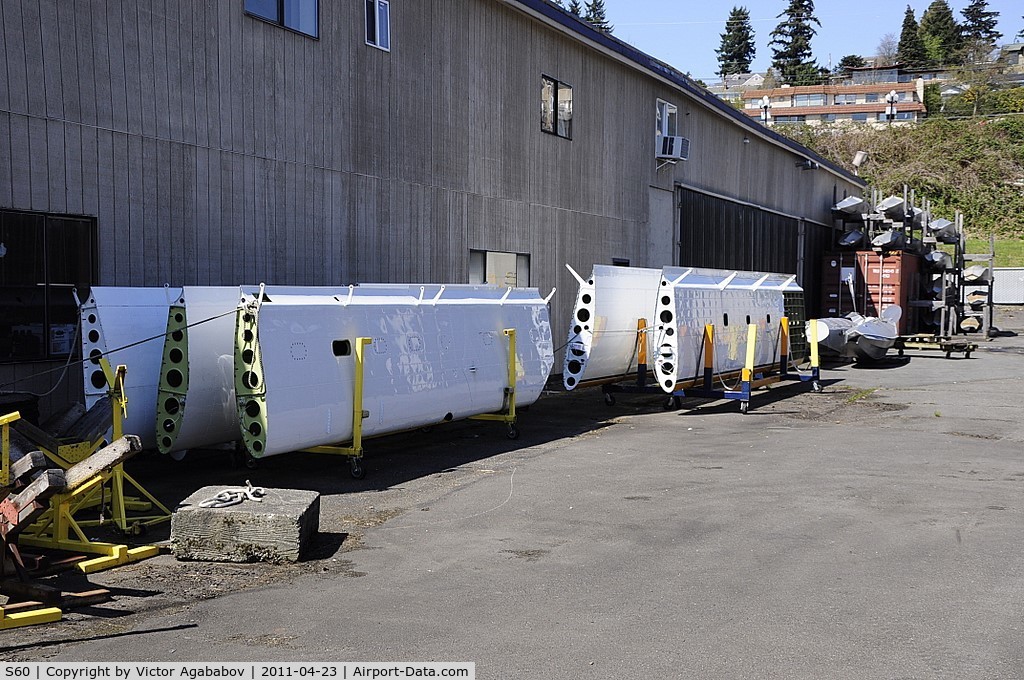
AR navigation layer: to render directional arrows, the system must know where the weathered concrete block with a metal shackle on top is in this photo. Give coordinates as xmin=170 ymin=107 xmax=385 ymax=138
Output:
xmin=171 ymin=486 xmax=319 ymax=562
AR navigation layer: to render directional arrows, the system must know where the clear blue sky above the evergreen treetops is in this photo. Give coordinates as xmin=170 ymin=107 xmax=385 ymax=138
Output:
xmin=605 ymin=0 xmax=1024 ymax=84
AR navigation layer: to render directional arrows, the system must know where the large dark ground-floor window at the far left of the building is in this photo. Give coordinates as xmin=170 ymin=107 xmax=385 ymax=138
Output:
xmin=0 ymin=210 xmax=96 ymax=362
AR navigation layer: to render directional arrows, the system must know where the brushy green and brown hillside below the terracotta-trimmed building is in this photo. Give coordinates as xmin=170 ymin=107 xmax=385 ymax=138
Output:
xmin=775 ymin=116 xmax=1024 ymax=241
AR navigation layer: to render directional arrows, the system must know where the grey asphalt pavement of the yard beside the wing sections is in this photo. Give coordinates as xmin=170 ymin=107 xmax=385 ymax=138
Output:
xmin=6 ymin=309 xmax=1024 ymax=679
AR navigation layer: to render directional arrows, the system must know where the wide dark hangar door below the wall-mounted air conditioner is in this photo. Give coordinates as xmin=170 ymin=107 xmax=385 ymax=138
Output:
xmin=677 ymin=187 xmax=829 ymax=288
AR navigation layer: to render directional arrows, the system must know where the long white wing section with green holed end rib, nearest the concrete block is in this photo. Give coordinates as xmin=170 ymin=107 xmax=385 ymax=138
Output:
xmin=234 ymin=285 xmax=554 ymax=458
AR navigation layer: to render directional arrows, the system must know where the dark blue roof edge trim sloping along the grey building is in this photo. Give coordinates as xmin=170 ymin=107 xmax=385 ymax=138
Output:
xmin=498 ymin=0 xmax=866 ymax=187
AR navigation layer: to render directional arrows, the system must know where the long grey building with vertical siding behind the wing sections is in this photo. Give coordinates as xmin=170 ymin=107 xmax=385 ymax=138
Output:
xmin=0 ymin=0 xmax=862 ymax=413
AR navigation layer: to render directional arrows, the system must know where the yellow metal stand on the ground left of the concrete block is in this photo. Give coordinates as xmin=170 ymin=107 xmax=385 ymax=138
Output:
xmin=16 ymin=358 xmax=171 ymax=573
